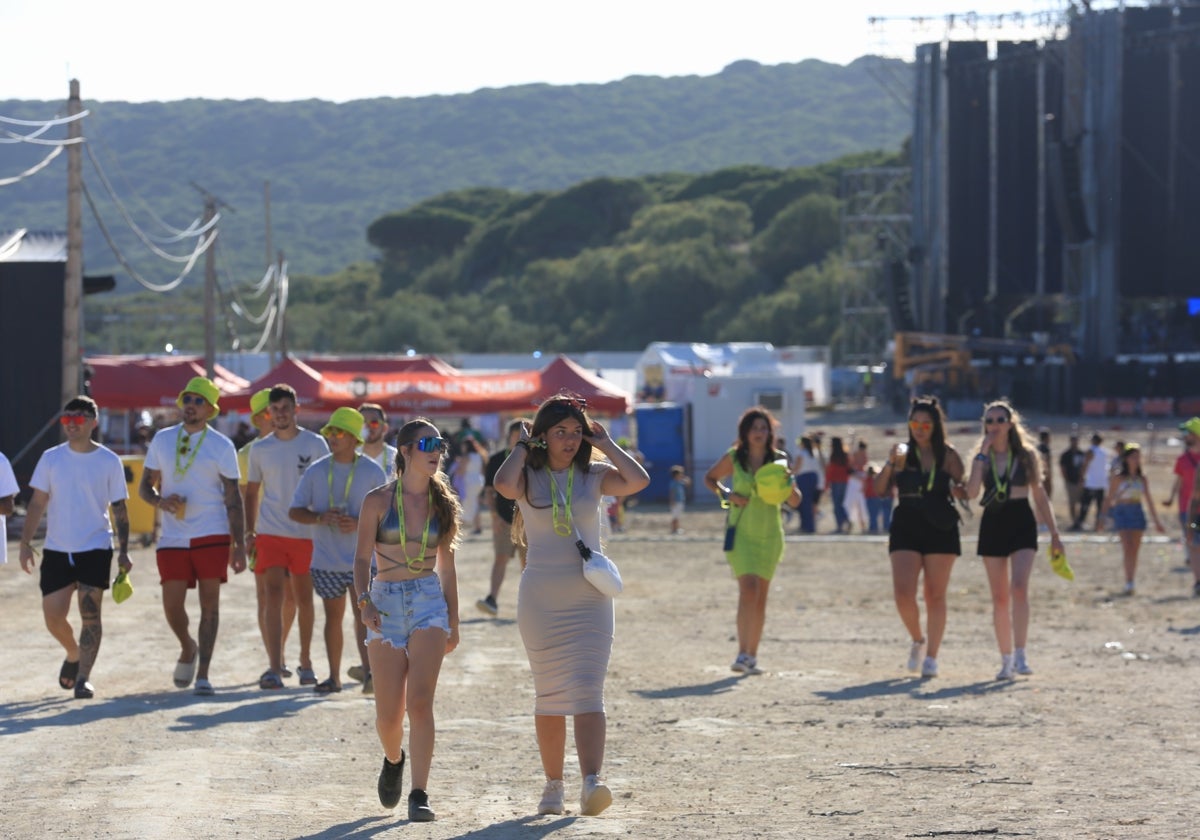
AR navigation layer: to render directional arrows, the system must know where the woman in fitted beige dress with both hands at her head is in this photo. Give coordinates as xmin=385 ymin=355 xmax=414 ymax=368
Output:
xmin=494 ymin=395 xmax=649 ymax=816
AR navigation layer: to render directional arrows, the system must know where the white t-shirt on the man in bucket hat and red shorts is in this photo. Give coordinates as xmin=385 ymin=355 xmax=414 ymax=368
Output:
xmin=145 ymin=424 xmax=238 ymax=548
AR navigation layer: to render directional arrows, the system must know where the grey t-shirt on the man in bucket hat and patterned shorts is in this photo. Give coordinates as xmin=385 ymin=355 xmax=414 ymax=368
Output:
xmin=292 ymin=455 xmax=385 ymax=571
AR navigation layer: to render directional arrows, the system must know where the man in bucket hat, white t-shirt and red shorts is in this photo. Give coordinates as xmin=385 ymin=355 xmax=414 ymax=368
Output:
xmin=138 ymin=377 xmax=246 ymax=697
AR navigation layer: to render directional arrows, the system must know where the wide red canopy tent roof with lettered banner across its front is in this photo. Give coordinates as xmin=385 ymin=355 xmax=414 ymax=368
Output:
xmin=222 ymin=356 xmax=632 ymax=416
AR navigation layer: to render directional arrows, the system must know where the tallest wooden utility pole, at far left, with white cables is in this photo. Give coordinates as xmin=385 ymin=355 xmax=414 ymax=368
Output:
xmin=59 ymin=79 xmax=83 ymax=406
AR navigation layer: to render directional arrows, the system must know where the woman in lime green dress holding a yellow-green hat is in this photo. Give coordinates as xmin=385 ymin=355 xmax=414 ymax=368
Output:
xmin=704 ymin=406 xmax=800 ymax=674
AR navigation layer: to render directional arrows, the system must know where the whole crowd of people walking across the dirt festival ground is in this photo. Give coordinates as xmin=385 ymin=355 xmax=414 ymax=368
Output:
xmin=0 ymin=377 xmax=1200 ymax=822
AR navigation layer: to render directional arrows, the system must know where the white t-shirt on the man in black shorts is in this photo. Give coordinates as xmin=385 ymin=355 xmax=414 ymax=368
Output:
xmin=29 ymin=443 xmax=130 ymax=553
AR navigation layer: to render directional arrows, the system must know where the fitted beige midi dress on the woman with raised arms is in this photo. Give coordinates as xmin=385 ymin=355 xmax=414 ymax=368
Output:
xmin=517 ymin=462 xmax=614 ymax=715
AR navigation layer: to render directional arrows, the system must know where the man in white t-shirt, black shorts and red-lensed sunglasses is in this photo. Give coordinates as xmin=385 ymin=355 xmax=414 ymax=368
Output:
xmin=20 ymin=396 xmax=133 ymax=700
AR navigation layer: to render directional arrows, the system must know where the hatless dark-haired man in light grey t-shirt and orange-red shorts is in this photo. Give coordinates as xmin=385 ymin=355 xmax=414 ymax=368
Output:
xmin=246 ymin=385 xmax=329 ymax=689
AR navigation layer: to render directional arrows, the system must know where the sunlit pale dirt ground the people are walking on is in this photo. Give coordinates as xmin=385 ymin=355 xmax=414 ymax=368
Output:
xmin=0 ymin=415 xmax=1200 ymax=840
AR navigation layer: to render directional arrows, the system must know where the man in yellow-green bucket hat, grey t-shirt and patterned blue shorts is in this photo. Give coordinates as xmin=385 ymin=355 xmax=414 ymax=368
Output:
xmin=288 ymin=408 xmax=386 ymax=694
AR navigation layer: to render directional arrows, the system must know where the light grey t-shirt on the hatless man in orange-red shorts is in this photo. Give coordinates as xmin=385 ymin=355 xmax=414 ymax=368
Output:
xmin=247 ymin=428 xmax=329 ymax=540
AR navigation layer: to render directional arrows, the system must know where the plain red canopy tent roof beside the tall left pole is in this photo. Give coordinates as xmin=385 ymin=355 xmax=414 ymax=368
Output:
xmin=84 ymin=355 xmax=250 ymax=410
